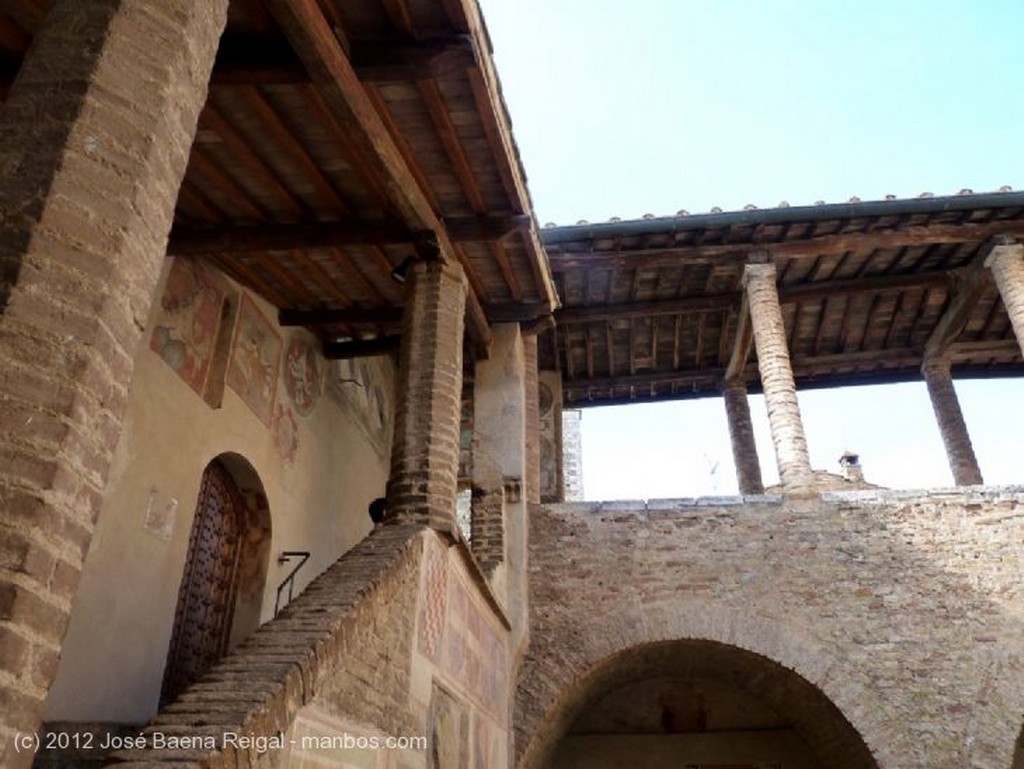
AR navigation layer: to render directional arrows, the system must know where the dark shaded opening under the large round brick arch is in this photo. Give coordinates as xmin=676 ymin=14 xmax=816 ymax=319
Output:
xmin=524 ymin=640 xmax=878 ymax=769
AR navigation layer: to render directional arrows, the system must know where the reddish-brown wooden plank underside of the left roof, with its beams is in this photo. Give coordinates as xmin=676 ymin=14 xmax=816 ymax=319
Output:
xmin=0 ymin=0 xmax=558 ymax=352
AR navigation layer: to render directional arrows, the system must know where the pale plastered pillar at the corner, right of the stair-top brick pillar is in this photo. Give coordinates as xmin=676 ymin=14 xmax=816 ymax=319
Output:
xmin=473 ymin=324 xmax=537 ymax=648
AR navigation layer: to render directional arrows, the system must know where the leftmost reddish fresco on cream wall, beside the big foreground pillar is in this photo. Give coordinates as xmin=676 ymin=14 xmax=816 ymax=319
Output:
xmin=150 ymin=259 xmax=236 ymax=397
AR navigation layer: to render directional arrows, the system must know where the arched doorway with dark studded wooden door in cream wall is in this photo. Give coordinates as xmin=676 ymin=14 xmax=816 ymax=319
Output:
xmin=160 ymin=455 xmax=270 ymax=706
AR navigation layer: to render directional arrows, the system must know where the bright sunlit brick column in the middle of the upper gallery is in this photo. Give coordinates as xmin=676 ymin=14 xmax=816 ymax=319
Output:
xmin=743 ymin=264 xmax=815 ymax=494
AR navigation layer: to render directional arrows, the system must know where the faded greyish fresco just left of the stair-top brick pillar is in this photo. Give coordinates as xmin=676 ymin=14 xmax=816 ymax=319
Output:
xmin=330 ymin=356 xmax=394 ymax=459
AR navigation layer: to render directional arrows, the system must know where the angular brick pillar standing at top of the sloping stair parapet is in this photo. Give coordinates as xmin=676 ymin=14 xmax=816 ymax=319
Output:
xmin=387 ymin=260 xmax=475 ymax=532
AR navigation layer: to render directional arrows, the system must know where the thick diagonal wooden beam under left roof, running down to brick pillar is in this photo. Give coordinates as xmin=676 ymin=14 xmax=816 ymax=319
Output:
xmin=266 ymin=0 xmax=493 ymax=357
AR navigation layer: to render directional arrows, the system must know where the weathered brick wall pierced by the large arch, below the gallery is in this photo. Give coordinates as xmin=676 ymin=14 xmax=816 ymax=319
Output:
xmin=516 ymin=488 xmax=1024 ymax=769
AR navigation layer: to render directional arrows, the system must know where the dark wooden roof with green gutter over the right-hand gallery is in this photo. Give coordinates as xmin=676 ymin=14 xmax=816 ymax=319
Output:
xmin=541 ymin=194 xmax=1024 ymax=404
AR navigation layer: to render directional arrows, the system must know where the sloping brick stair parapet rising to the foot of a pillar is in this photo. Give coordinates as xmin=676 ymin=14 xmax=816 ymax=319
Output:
xmin=100 ymin=524 xmax=428 ymax=769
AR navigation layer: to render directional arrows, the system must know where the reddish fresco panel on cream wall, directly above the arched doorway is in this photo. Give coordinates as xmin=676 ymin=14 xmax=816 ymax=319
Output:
xmin=227 ymin=295 xmax=283 ymax=427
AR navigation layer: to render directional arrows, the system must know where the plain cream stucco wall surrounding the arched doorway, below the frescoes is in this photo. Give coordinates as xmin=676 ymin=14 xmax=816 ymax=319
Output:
xmin=45 ymin=269 xmax=394 ymax=722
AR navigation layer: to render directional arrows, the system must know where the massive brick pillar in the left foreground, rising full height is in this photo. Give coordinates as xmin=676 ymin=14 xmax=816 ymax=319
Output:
xmin=0 ymin=0 xmax=227 ymax=767
